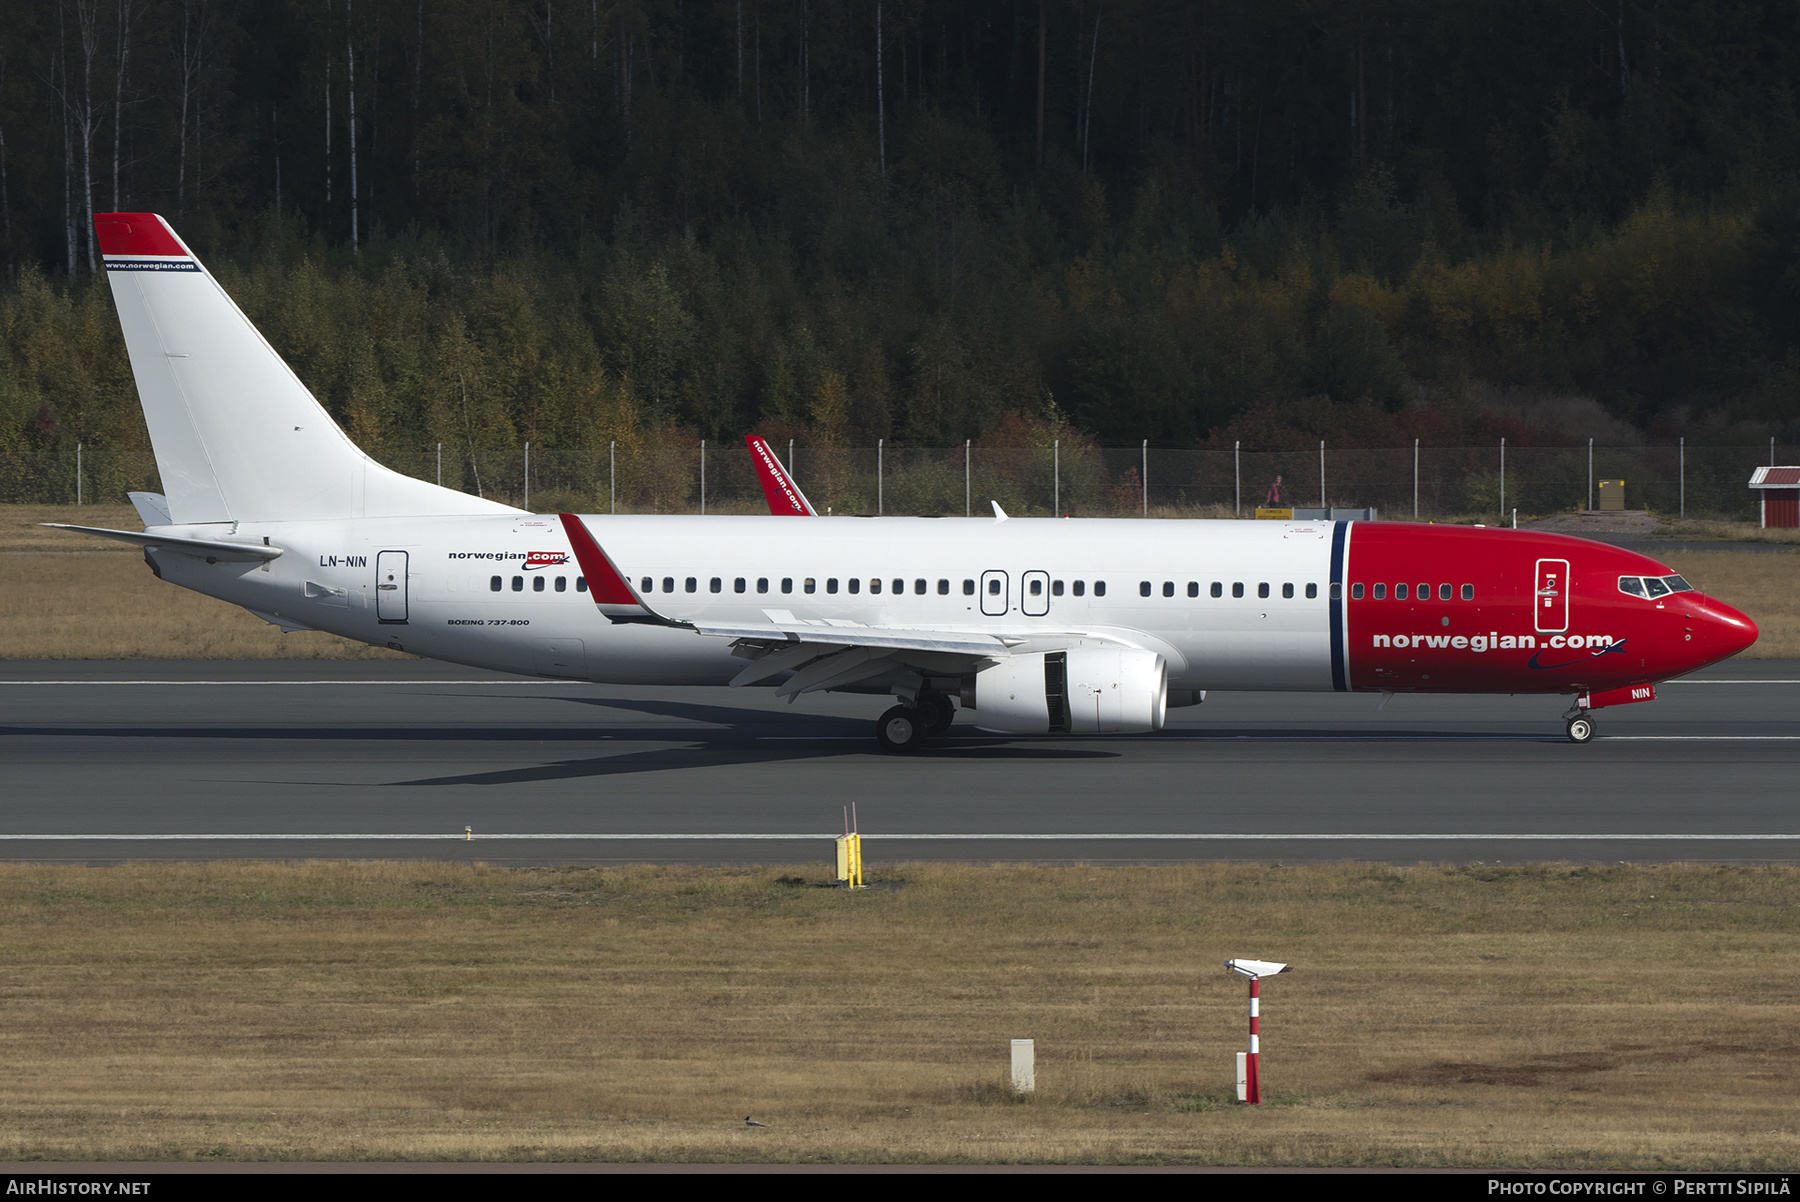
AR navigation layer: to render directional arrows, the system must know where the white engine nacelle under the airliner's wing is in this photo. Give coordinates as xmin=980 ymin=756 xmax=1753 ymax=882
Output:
xmin=972 ymin=648 xmax=1168 ymax=734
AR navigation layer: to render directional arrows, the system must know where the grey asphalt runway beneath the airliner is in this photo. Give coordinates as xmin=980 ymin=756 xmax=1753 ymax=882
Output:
xmin=0 ymin=660 xmax=1800 ymax=864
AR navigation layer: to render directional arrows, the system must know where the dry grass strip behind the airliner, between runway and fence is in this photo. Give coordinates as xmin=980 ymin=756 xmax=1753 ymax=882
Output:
xmin=0 ymin=506 xmax=1800 ymax=659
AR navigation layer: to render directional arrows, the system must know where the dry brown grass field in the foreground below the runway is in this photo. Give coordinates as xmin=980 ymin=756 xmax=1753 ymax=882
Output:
xmin=0 ymin=860 xmax=1800 ymax=1170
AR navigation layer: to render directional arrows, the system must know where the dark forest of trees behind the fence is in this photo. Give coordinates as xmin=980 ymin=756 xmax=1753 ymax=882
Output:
xmin=0 ymin=0 xmax=1800 ymax=503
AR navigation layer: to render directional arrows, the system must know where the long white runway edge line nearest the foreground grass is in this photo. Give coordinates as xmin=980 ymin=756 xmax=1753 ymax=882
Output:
xmin=0 ymin=831 xmax=1800 ymax=842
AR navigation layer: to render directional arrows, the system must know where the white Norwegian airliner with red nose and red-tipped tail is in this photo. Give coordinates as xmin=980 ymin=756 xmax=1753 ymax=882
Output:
xmin=68 ymin=212 xmax=1757 ymax=750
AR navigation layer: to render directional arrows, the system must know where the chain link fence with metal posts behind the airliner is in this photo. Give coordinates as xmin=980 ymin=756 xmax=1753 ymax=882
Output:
xmin=0 ymin=441 xmax=1800 ymax=522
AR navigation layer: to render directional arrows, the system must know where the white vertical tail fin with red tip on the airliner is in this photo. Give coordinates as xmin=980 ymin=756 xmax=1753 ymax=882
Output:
xmin=94 ymin=212 xmax=517 ymax=524
